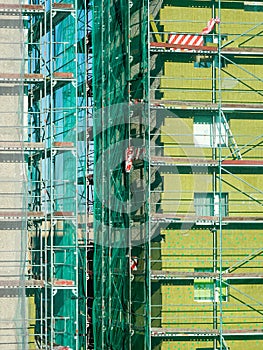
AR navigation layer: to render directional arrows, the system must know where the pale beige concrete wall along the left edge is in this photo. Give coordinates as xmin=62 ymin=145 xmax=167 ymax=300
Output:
xmin=0 ymin=0 xmax=27 ymax=350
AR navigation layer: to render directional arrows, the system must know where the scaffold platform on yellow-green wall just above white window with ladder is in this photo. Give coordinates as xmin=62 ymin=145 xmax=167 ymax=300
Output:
xmin=151 ymin=100 xmax=263 ymax=112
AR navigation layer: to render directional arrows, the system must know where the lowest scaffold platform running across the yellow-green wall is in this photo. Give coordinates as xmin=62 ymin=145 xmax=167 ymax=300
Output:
xmin=151 ymin=328 xmax=263 ymax=339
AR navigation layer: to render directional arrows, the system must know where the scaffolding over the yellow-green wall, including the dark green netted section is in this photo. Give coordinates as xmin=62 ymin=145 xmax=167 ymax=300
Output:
xmin=93 ymin=0 xmax=263 ymax=350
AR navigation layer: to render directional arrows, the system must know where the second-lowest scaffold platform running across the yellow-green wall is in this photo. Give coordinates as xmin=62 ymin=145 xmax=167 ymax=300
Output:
xmin=151 ymin=270 xmax=263 ymax=280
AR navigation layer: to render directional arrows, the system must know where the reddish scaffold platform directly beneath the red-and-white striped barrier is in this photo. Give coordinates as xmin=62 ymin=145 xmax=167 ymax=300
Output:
xmin=150 ymin=42 xmax=263 ymax=56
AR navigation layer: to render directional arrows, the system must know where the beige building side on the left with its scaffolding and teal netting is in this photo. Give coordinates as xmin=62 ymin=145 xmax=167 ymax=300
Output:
xmin=0 ymin=0 xmax=90 ymax=350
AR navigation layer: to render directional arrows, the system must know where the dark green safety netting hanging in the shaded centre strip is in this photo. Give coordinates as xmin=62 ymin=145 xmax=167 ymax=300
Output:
xmin=92 ymin=0 xmax=149 ymax=350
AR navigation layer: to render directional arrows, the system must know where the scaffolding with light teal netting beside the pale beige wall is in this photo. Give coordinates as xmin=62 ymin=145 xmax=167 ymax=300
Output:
xmin=0 ymin=0 xmax=91 ymax=350
